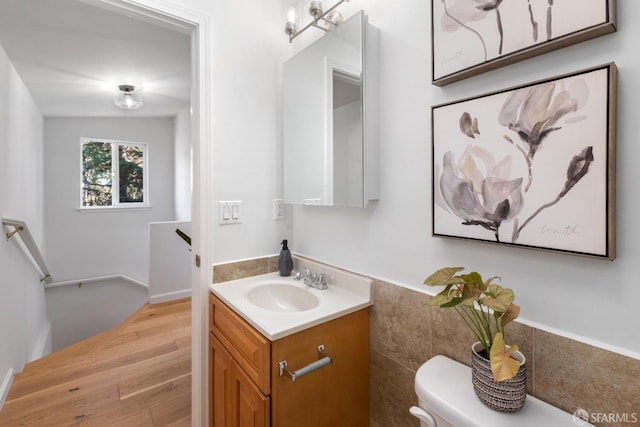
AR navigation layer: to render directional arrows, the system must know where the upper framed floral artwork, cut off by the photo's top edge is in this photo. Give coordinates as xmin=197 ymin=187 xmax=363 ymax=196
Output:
xmin=431 ymin=0 xmax=616 ymax=86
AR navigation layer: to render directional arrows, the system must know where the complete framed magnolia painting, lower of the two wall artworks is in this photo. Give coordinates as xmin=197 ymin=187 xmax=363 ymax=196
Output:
xmin=431 ymin=63 xmax=617 ymax=260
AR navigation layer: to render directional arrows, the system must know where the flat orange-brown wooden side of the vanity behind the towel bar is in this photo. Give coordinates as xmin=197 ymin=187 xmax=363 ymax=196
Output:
xmin=271 ymin=308 xmax=370 ymax=427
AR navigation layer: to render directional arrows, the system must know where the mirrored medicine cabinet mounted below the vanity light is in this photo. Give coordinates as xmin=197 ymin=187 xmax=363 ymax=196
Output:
xmin=283 ymin=11 xmax=378 ymax=207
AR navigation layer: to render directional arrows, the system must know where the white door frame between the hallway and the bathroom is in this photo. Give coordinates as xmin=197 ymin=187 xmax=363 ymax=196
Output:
xmin=89 ymin=0 xmax=215 ymax=427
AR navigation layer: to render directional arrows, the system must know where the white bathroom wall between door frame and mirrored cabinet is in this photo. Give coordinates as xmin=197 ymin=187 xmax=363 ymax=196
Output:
xmin=211 ymin=0 xmax=291 ymax=263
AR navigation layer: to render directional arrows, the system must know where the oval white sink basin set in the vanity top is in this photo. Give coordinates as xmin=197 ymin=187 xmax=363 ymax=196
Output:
xmin=247 ymin=282 xmax=320 ymax=312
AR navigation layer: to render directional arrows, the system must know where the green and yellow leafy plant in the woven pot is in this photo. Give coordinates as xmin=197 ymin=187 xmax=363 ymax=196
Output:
xmin=424 ymin=267 xmax=520 ymax=381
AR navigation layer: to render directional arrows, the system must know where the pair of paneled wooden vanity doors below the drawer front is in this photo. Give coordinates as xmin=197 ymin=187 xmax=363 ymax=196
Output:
xmin=209 ymin=334 xmax=270 ymax=427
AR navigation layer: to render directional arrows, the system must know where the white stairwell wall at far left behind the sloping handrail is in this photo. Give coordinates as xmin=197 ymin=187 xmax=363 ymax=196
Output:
xmin=0 ymin=47 xmax=50 ymax=406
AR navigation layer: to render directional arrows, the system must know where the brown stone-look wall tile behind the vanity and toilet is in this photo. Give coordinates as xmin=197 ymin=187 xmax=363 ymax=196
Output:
xmin=213 ymin=256 xmax=640 ymax=427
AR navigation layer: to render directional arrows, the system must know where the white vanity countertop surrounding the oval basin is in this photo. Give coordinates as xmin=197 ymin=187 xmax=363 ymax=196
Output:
xmin=210 ymin=260 xmax=373 ymax=341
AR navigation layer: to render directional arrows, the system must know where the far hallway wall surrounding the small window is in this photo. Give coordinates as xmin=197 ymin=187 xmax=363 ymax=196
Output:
xmin=44 ymin=118 xmax=174 ymax=283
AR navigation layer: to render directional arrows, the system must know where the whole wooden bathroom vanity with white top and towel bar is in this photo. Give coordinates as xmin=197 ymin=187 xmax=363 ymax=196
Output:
xmin=209 ymin=264 xmax=372 ymax=427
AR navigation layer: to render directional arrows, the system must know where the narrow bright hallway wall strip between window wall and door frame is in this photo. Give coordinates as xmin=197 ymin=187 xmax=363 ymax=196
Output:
xmin=174 ymin=105 xmax=192 ymax=221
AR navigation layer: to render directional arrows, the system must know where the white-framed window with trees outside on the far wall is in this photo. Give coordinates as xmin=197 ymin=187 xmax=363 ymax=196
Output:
xmin=80 ymin=139 xmax=148 ymax=208
